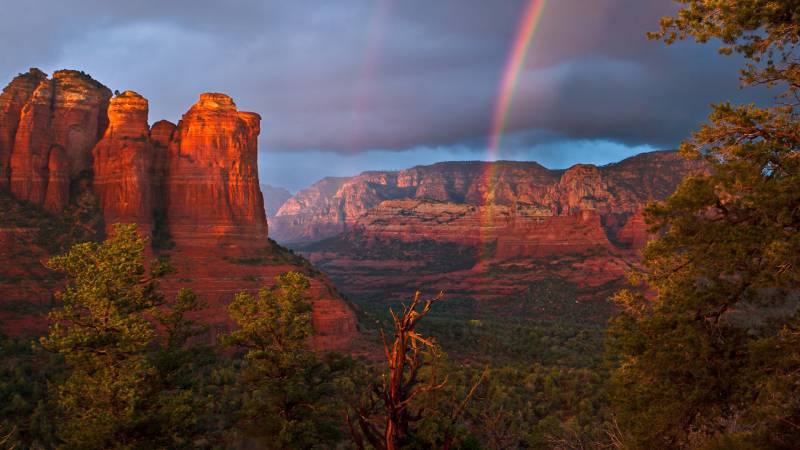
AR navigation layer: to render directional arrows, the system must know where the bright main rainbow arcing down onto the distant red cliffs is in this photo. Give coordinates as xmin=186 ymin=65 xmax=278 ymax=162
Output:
xmin=481 ymin=0 xmax=547 ymax=259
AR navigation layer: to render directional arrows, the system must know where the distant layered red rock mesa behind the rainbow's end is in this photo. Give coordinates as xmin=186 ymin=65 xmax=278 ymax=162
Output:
xmin=270 ymin=152 xmax=698 ymax=306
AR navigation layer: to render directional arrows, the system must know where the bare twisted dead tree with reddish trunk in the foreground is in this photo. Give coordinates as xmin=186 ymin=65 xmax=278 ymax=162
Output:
xmin=346 ymin=292 xmax=484 ymax=450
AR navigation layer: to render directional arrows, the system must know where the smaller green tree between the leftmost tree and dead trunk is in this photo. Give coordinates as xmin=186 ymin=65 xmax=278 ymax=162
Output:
xmin=223 ymin=272 xmax=347 ymax=449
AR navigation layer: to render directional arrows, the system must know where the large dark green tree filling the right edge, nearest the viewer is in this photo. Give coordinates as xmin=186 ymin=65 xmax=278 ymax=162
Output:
xmin=609 ymin=0 xmax=800 ymax=448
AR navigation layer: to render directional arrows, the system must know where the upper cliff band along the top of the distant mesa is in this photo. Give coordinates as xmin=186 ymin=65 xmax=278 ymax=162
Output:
xmin=270 ymin=152 xmax=694 ymax=243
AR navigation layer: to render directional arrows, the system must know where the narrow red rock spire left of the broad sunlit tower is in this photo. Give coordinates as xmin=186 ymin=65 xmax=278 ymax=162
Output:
xmin=92 ymin=91 xmax=154 ymax=235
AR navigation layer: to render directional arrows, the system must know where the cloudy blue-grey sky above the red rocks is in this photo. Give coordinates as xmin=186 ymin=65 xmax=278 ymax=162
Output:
xmin=0 ymin=0 xmax=767 ymax=191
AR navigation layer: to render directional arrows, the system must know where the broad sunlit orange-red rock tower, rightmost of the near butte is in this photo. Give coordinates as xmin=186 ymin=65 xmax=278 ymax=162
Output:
xmin=166 ymin=94 xmax=267 ymax=247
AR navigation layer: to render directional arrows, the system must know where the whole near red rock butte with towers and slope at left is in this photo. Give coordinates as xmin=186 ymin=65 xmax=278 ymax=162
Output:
xmin=0 ymin=69 xmax=356 ymax=348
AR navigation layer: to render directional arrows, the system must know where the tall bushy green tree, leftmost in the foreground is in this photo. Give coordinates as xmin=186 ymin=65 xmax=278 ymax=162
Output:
xmin=41 ymin=225 xmax=209 ymax=448
